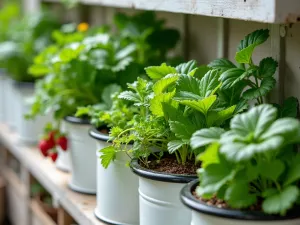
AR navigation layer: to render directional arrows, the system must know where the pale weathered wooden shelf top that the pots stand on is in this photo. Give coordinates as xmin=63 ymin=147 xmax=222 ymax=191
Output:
xmin=0 ymin=124 xmax=105 ymax=225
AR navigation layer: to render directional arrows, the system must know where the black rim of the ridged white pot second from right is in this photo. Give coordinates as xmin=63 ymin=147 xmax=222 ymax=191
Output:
xmin=130 ymin=159 xmax=197 ymax=183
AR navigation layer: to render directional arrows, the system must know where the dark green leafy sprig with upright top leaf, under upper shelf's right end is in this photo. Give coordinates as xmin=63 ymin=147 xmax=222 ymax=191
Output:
xmin=208 ymin=29 xmax=278 ymax=104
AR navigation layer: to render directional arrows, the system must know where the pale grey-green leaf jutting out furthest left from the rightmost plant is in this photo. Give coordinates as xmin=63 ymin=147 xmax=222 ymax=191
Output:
xmin=191 ymin=127 xmax=225 ymax=149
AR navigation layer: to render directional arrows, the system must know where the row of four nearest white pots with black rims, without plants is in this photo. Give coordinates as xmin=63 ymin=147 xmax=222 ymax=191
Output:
xmin=62 ymin=121 xmax=300 ymax=225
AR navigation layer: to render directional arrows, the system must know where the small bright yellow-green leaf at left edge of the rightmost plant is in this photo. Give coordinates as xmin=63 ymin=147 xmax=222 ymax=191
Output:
xmin=197 ymin=143 xmax=220 ymax=168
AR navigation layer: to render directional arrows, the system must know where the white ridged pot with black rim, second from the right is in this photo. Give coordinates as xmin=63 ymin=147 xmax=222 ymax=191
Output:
xmin=130 ymin=159 xmax=196 ymax=225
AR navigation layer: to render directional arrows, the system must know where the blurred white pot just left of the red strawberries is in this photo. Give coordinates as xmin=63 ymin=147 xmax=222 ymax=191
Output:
xmin=13 ymin=82 xmax=52 ymax=144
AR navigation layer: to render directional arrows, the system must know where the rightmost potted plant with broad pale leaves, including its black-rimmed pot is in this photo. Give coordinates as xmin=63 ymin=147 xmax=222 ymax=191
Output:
xmin=181 ymin=104 xmax=300 ymax=225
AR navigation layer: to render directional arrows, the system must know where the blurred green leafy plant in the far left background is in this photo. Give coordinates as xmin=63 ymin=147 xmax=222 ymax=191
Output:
xmin=0 ymin=11 xmax=60 ymax=81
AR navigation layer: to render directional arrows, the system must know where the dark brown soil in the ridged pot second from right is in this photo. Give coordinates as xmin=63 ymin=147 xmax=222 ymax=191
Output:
xmin=149 ymin=155 xmax=199 ymax=175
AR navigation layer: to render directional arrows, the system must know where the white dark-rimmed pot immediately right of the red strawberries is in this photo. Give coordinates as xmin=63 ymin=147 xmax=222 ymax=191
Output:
xmin=65 ymin=116 xmax=97 ymax=194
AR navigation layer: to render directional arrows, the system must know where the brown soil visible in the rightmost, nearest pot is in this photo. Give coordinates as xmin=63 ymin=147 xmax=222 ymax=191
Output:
xmin=193 ymin=191 xmax=262 ymax=211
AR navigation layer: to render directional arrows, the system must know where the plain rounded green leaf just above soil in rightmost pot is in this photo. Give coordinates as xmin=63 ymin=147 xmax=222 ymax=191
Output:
xmin=225 ymin=181 xmax=257 ymax=209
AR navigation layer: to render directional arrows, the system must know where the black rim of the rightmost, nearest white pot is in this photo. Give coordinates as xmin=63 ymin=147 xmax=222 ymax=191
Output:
xmin=180 ymin=179 xmax=300 ymax=221
